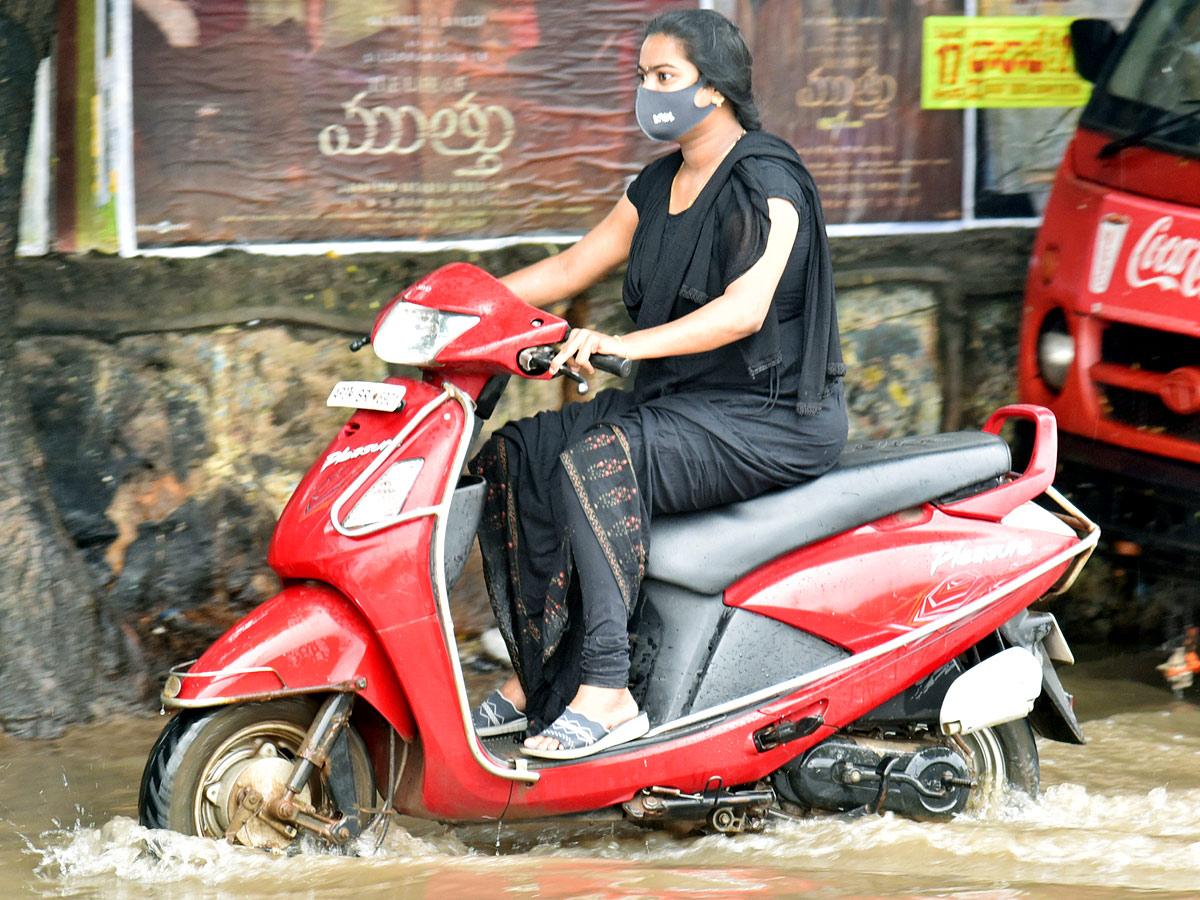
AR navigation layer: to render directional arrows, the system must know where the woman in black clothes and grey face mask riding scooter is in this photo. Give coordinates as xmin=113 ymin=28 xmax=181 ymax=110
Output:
xmin=472 ymin=10 xmax=846 ymax=758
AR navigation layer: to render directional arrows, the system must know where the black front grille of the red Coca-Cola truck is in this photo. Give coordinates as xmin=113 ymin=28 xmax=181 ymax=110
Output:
xmin=1094 ymin=323 xmax=1200 ymax=442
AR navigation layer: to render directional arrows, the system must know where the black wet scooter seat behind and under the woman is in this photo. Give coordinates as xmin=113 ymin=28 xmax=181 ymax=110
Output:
xmin=646 ymin=431 xmax=1012 ymax=595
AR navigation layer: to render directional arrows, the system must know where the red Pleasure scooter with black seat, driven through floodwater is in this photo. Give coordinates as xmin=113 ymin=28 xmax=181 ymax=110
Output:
xmin=139 ymin=264 xmax=1099 ymax=848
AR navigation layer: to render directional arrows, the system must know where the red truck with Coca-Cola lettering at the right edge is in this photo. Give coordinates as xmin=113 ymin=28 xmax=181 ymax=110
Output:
xmin=1019 ymin=0 xmax=1200 ymax=576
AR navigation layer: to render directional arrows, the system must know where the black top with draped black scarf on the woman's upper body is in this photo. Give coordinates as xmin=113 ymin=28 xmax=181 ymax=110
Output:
xmin=624 ymin=132 xmax=845 ymax=415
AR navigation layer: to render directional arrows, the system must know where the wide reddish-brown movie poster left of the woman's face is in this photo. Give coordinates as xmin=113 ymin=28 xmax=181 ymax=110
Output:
xmin=132 ymin=0 xmax=694 ymax=247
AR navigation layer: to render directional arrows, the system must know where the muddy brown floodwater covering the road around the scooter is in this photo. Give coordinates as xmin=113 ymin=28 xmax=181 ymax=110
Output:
xmin=0 ymin=654 xmax=1200 ymax=900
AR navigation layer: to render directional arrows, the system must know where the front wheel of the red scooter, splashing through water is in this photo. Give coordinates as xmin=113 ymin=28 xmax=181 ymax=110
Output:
xmin=138 ymin=697 xmax=376 ymax=850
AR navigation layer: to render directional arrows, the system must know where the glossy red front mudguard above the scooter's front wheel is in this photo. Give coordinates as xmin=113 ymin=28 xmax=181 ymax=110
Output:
xmin=162 ymin=582 xmax=416 ymax=742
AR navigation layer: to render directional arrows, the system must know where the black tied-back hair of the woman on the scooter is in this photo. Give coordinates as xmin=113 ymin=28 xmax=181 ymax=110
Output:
xmin=642 ymin=10 xmax=762 ymax=131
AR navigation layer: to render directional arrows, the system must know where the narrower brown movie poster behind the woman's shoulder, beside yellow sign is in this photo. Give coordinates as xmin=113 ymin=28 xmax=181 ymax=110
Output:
xmin=738 ymin=0 xmax=962 ymax=224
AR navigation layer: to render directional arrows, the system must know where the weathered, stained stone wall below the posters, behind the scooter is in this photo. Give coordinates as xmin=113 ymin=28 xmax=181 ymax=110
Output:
xmin=9 ymin=230 xmax=1032 ymax=686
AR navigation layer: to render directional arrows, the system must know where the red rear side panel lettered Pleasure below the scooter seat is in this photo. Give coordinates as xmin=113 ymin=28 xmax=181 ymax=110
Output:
xmin=726 ymin=506 xmax=1076 ymax=653
